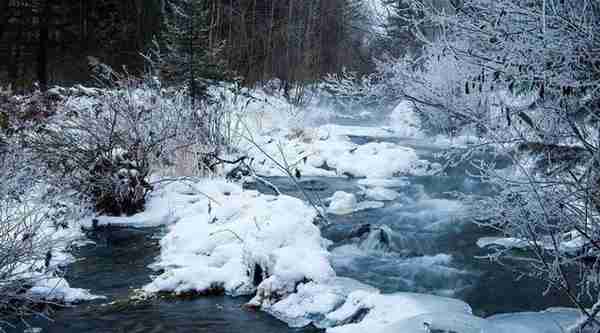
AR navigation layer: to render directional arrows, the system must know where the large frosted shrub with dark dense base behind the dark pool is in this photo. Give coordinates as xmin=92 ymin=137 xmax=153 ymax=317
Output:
xmin=22 ymin=76 xmax=202 ymax=215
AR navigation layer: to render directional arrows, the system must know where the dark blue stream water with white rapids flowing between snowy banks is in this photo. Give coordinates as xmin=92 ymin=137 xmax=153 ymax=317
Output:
xmin=8 ymin=137 xmax=569 ymax=333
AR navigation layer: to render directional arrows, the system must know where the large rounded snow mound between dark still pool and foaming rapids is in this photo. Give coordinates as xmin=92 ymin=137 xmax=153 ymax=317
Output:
xmin=143 ymin=180 xmax=334 ymax=295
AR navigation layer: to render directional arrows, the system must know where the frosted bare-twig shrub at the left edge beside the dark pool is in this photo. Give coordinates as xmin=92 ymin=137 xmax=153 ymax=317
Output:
xmin=0 ymin=137 xmax=93 ymax=331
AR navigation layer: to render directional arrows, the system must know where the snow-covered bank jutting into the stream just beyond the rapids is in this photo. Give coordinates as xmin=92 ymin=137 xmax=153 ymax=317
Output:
xmin=226 ymin=97 xmax=432 ymax=178
